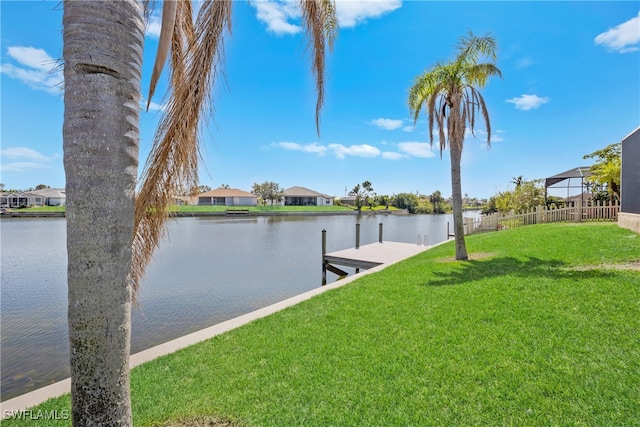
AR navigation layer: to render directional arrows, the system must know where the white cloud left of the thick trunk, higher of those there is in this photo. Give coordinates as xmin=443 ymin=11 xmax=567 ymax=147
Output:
xmin=0 ymin=46 xmax=63 ymax=94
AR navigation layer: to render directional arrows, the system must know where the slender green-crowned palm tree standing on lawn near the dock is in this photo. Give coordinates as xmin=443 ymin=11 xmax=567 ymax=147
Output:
xmin=408 ymin=32 xmax=502 ymax=260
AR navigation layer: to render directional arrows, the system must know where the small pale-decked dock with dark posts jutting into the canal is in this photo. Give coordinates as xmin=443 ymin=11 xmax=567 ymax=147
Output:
xmin=322 ymin=242 xmax=430 ymax=285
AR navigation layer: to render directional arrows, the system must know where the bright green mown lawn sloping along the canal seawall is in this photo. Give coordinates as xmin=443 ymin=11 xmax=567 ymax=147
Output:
xmin=7 ymin=224 xmax=640 ymax=426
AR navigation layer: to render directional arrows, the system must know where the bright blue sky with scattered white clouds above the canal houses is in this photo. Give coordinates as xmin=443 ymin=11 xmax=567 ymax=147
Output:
xmin=0 ymin=0 xmax=640 ymax=198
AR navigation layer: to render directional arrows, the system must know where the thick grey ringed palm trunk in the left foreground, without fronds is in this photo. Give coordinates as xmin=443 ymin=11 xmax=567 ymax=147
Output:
xmin=63 ymin=0 xmax=144 ymax=426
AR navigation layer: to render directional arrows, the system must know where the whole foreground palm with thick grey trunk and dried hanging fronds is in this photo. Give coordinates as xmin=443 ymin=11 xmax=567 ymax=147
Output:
xmin=63 ymin=0 xmax=336 ymax=426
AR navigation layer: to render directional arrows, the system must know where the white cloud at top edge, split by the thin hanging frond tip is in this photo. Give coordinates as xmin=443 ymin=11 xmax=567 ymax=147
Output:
xmin=251 ymin=0 xmax=402 ymax=35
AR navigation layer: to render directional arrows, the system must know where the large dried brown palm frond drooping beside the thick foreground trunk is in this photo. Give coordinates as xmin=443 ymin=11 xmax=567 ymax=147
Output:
xmin=132 ymin=0 xmax=232 ymax=295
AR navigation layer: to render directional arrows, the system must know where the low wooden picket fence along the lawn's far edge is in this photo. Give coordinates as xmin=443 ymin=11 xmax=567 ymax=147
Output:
xmin=464 ymin=203 xmax=620 ymax=234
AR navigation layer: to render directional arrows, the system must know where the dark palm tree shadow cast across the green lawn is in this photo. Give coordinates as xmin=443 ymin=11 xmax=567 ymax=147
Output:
xmin=425 ymin=257 xmax=614 ymax=286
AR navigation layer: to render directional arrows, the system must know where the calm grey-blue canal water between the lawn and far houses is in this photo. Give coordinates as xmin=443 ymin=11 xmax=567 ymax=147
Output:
xmin=0 ymin=212 xmax=477 ymax=400
